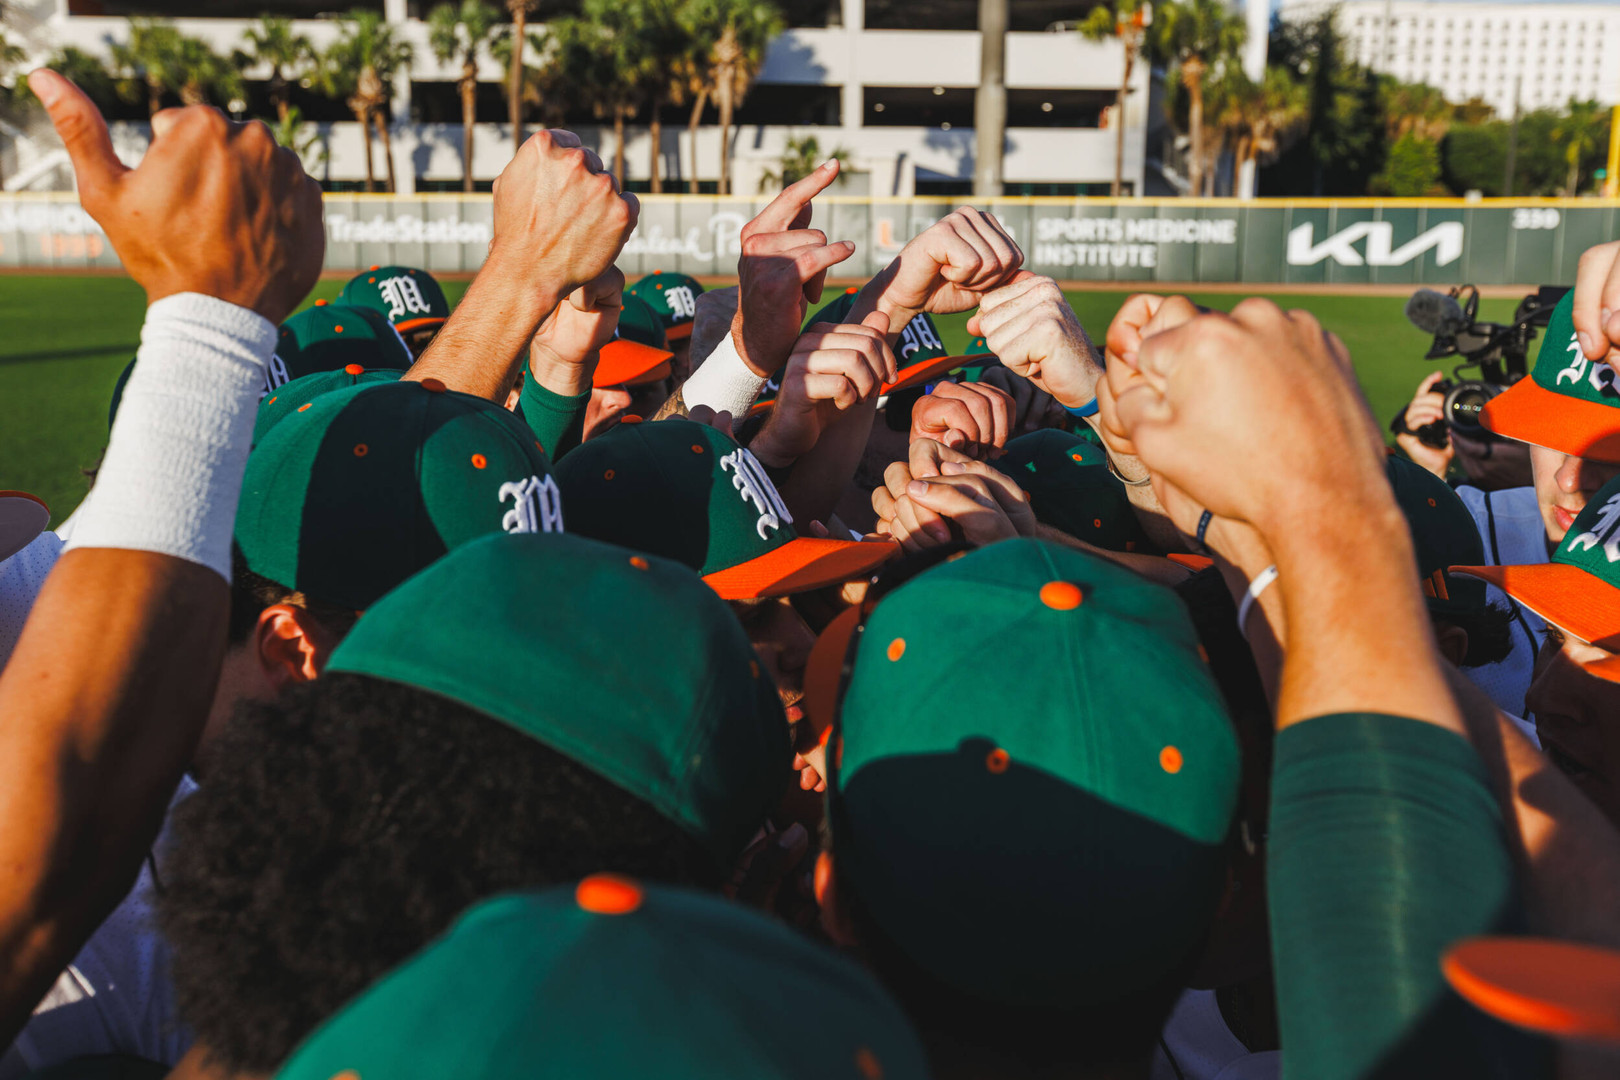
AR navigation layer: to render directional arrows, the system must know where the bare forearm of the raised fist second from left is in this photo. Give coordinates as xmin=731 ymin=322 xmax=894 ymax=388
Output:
xmin=403 ymin=254 xmax=564 ymax=405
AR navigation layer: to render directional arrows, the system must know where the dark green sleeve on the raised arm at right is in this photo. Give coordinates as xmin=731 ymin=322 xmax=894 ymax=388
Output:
xmin=1267 ymin=714 xmax=1552 ymax=1080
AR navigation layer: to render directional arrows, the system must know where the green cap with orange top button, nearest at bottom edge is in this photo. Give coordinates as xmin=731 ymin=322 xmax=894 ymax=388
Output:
xmin=277 ymin=874 xmax=928 ymax=1080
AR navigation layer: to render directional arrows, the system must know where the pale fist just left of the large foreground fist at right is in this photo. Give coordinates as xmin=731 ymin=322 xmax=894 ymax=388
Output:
xmin=967 ymin=270 xmax=1103 ymax=408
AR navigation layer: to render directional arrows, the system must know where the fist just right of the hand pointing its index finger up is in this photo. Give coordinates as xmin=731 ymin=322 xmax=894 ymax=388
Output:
xmin=857 ymin=206 xmax=1024 ymax=334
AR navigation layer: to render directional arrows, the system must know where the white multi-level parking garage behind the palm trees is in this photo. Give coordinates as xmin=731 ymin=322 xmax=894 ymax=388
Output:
xmin=0 ymin=0 xmax=1150 ymax=196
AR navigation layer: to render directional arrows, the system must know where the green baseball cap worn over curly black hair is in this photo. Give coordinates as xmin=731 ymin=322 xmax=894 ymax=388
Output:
xmin=329 ymin=533 xmax=792 ymax=870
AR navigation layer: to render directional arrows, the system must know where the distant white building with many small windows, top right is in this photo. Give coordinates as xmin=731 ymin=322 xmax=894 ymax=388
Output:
xmin=1281 ymin=0 xmax=1620 ymax=117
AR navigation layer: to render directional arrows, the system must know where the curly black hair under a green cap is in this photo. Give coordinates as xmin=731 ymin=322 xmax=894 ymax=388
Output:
xmin=159 ymin=674 xmax=721 ymax=1074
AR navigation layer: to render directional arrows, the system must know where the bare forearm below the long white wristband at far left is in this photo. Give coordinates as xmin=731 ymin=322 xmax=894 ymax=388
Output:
xmin=0 ymin=549 xmax=230 ymax=1043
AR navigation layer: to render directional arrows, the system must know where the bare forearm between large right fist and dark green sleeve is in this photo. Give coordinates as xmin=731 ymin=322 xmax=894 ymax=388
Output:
xmin=1265 ymin=497 xmax=1464 ymax=735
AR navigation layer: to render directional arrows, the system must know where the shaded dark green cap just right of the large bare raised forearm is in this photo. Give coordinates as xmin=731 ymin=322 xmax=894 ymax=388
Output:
xmin=1385 ymin=453 xmax=1489 ymax=619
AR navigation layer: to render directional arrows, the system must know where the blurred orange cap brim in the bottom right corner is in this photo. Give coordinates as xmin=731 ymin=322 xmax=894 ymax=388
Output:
xmin=1440 ymin=938 xmax=1620 ymax=1044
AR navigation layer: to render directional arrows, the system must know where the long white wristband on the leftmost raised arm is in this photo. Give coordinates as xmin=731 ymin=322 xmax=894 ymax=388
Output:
xmin=65 ymin=293 xmax=275 ymax=581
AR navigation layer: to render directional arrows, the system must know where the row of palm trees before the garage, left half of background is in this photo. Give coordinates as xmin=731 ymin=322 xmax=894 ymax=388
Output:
xmin=0 ymin=0 xmax=786 ymax=194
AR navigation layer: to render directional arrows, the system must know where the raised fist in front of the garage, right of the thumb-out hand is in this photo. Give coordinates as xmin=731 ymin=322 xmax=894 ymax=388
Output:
xmin=489 ymin=131 xmax=642 ymax=296
